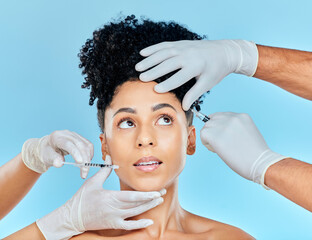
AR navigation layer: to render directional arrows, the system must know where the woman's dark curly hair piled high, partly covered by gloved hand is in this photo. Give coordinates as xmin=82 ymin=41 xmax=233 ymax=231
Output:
xmin=78 ymin=15 xmax=204 ymax=131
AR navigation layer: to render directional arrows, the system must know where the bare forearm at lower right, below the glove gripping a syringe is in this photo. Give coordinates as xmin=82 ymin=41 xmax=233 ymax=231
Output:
xmin=265 ymin=158 xmax=312 ymax=211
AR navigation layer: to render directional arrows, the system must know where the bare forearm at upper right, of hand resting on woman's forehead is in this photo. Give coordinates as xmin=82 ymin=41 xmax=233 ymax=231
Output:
xmin=254 ymin=45 xmax=312 ymax=100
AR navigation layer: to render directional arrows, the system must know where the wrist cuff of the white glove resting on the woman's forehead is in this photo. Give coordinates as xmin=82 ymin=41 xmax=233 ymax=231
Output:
xmin=230 ymin=40 xmax=259 ymax=77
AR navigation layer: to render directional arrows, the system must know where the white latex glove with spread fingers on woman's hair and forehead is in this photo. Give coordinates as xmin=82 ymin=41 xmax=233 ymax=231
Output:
xmin=135 ymin=40 xmax=258 ymax=111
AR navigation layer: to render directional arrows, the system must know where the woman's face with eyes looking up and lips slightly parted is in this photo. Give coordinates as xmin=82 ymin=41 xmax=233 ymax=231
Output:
xmin=100 ymin=81 xmax=196 ymax=191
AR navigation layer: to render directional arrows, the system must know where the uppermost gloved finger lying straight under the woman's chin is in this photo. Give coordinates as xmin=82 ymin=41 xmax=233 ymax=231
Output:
xmin=115 ymin=191 xmax=162 ymax=202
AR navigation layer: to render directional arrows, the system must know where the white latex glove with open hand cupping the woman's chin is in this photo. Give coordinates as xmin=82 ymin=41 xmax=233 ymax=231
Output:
xmin=37 ymin=156 xmax=166 ymax=240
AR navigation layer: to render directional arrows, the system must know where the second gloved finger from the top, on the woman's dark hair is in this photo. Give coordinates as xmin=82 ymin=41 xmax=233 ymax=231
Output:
xmin=135 ymin=49 xmax=175 ymax=72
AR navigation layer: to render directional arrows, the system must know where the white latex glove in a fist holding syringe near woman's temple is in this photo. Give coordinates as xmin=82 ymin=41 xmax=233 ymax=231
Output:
xmin=200 ymin=112 xmax=287 ymax=189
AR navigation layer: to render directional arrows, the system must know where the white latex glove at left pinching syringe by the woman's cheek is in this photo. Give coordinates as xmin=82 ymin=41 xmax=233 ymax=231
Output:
xmin=22 ymin=130 xmax=94 ymax=178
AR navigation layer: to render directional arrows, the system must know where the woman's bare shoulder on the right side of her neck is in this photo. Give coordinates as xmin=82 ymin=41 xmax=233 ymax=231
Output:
xmin=183 ymin=211 xmax=254 ymax=239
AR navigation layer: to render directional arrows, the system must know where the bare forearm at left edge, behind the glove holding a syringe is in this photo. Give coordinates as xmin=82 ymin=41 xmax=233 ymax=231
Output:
xmin=0 ymin=154 xmax=40 ymax=219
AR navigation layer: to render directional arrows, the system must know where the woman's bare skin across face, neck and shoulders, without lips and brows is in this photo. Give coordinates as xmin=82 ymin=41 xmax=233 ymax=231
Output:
xmin=72 ymin=81 xmax=253 ymax=239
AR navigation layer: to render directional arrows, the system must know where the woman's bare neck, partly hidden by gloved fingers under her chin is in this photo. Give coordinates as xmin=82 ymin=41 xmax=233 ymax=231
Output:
xmin=121 ymin=178 xmax=184 ymax=238
